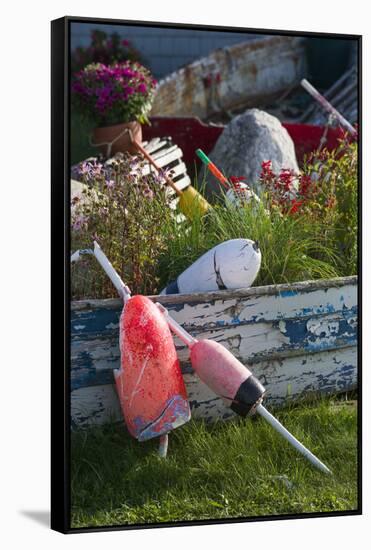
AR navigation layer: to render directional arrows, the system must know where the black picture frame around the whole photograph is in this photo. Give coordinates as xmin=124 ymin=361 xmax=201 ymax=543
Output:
xmin=51 ymin=17 xmax=362 ymax=533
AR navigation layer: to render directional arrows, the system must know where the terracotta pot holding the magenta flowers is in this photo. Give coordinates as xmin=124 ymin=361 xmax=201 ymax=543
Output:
xmin=93 ymin=121 xmax=142 ymax=157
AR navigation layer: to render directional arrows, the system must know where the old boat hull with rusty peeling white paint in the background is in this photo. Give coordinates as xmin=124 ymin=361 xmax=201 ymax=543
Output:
xmin=151 ymin=36 xmax=306 ymax=118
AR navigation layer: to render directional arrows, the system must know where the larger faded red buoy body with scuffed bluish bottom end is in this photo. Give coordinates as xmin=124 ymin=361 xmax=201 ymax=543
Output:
xmin=115 ymin=295 xmax=191 ymax=441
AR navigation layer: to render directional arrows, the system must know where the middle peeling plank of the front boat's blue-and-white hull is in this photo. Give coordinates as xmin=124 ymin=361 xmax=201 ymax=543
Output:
xmin=71 ymin=308 xmax=357 ymax=389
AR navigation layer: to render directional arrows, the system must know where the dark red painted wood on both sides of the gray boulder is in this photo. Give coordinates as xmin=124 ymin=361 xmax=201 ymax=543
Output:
xmin=143 ymin=117 xmax=343 ymax=173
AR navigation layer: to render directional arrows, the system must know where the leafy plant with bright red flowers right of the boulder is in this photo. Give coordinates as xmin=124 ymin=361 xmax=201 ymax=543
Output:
xmin=261 ymin=136 xmax=358 ymax=274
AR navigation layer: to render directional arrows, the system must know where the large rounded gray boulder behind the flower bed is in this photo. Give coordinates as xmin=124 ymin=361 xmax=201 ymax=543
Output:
xmin=200 ymin=109 xmax=299 ymax=196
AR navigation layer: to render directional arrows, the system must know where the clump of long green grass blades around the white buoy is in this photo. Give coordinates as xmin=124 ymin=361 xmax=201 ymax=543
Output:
xmin=159 ymin=202 xmax=340 ymax=292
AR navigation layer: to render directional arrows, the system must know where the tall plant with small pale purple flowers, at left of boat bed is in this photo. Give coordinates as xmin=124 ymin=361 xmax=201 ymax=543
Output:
xmin=71 ymin=153 xmax=171 ymax=299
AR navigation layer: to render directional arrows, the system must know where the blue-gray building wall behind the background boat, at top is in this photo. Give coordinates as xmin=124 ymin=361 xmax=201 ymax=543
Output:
xmin=71 ymin=23 xmax=264 ymax=79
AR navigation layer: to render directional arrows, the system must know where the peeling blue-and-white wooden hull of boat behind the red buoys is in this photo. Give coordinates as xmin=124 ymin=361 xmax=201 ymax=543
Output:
xmin=71 ymin=277 xmax=357 ymax=426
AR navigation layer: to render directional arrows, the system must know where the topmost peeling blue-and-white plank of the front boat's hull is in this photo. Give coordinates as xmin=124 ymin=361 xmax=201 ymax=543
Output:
xmin=71 ymin=280 xmax=357 ymax=335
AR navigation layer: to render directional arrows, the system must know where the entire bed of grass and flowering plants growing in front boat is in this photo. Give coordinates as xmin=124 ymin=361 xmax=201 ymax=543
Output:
xmin=73 ymin=142 xmax=358 ymax=298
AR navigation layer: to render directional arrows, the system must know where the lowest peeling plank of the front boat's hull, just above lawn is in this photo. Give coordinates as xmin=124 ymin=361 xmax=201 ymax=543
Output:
xmin=71 ymin=347 xmax=357 ymax=426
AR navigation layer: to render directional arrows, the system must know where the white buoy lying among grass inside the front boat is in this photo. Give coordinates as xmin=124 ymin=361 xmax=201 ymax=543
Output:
xmin=161 ymin=239 xmax=261 ymax=294
